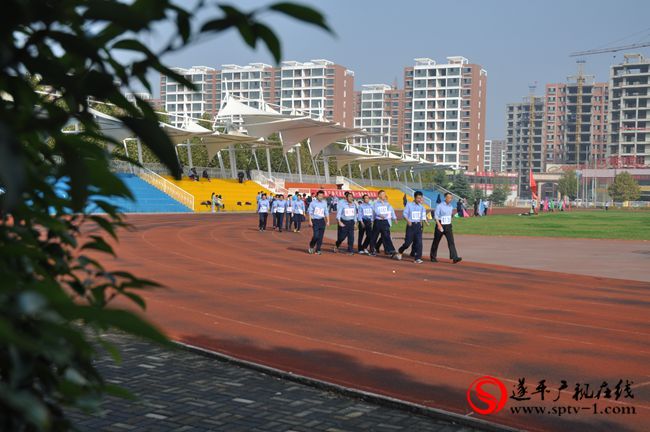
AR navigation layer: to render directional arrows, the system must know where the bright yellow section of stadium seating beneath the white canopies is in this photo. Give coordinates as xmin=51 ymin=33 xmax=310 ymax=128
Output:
xmin=165 ymin=176 xmax=270 ymax=212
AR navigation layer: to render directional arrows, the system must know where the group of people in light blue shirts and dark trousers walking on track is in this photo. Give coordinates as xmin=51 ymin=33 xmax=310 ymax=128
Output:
xmin=257 ymin=190 xmax=462 ymax=264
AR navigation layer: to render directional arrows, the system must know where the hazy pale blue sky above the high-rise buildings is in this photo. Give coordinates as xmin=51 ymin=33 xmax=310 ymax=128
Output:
xmin=149 ymin=0 xmax=650 ymax=139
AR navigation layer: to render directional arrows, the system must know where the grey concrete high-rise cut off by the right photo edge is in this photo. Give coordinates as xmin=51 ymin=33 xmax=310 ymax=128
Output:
xmin=607 ymin=54 xmax=650 ymax=166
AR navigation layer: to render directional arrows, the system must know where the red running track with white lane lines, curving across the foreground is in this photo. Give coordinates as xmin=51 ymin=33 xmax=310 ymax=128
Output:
xmin=98 ymin=214 xmax=650 ymax=431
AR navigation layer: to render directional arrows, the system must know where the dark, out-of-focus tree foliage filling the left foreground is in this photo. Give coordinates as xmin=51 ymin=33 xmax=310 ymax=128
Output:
xmin=0 ymin=0 xmax=328 ymax=431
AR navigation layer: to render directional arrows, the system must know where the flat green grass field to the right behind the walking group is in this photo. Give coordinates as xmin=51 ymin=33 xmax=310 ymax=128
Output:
xmin=330 ymin=210 xmax=650 ymax=240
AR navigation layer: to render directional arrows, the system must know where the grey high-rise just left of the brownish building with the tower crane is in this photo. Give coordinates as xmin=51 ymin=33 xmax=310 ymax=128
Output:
xmin=506 ymin=95 xmax=544 ymax=197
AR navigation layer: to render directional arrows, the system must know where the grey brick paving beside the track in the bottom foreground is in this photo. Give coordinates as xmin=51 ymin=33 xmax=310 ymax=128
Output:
xmin=73 ymin=334 xmax=486 ymax=432
